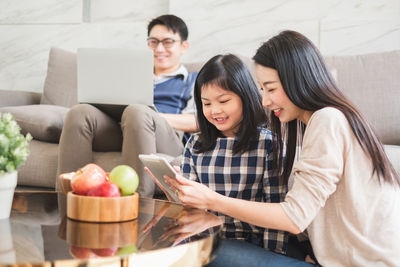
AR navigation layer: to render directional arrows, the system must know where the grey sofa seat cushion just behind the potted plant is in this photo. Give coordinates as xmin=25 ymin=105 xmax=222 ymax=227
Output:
xmin=0 ymin=105 xmax=69 ymax=143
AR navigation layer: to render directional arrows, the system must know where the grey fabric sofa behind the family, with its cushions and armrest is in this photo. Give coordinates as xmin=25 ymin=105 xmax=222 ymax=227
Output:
xmin=0 ymin=48 xmax=400 ymax=191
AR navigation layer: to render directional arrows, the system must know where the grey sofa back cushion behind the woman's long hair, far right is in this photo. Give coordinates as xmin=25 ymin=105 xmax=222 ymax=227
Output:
xmin=325 ymin=51 xmax=400 ymax=145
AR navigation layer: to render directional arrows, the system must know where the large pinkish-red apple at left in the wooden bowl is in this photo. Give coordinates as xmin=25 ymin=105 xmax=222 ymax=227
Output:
xmin=71 ymin=163 xmax=107 ymax=195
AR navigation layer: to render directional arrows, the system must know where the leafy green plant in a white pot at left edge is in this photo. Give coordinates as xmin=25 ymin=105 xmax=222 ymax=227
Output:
xmin=0 ymin=113 xmax=32 ymax=219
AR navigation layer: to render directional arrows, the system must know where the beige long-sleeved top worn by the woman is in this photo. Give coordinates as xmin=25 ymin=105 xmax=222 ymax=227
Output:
xmin=281 ymin=108 xmax=400 ymax=266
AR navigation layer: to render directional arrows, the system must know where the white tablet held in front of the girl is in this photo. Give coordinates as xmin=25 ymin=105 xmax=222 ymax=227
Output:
xmin=139 ymin=154 xmax=180 ymax=203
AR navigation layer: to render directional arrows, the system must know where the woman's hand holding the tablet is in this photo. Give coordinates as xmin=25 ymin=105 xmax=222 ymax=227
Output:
xmin=164 ymin=174 xmax=220 ymax=210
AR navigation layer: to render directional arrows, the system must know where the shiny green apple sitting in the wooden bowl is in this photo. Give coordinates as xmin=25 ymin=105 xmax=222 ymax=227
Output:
xmin=109 ymin=165 xmax=139 ymax=196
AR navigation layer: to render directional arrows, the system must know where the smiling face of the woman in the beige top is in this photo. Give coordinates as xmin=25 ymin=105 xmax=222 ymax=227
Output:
xmin=256 ymin=64 xmax=312 ymax=124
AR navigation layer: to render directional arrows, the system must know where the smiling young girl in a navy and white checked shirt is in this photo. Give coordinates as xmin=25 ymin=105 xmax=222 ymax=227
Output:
xmin=174 ymin=54 xmax=287 ymax=253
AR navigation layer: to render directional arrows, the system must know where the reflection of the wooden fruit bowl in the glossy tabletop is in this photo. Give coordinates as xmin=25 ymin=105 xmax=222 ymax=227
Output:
xmin=66 ymin=219 xmax=138 ymax=248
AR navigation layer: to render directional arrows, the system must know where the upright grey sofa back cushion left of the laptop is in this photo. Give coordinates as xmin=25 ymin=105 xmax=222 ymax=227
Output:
xmin=40 ymin=47 xmax=78 ymax=107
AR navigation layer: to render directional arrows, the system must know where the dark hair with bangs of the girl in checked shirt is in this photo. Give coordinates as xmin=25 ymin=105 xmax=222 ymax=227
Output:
xmin=194 ymin=54 xmax=266 ymax=153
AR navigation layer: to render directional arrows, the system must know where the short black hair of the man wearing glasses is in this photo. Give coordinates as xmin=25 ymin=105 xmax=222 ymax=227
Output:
xmin=147 ymin=14 xmax=189 ymax=42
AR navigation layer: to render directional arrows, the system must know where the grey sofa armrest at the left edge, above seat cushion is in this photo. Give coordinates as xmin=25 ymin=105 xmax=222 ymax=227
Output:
xmin=0 ymin=90 xmax=42 ymax=107
